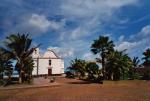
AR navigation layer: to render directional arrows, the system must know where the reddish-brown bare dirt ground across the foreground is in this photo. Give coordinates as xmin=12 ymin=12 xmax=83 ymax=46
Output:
xmin=0 ymin=77 xmax=150 ymax=101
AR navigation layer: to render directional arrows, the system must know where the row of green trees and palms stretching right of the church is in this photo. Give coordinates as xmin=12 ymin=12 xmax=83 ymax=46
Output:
xmin=66 ymin=36 xmax=150 ymax=80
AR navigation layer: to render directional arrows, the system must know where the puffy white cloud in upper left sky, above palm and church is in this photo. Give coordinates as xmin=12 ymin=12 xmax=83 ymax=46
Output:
xmin=5 ymin=13 xmax=65 ymax=37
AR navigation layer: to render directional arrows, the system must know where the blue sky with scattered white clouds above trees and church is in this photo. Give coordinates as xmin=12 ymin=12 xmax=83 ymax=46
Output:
xmin=0 ymin=0 xmax=150 ymax=67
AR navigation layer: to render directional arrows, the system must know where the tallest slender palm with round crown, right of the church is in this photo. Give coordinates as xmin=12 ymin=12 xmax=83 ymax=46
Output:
xmin=91 ymin=36 xmax=114 ymax=79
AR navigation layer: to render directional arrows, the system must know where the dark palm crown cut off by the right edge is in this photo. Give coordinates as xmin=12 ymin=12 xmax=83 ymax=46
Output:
xmin=143 ymin=48 xmax=150 ymax=67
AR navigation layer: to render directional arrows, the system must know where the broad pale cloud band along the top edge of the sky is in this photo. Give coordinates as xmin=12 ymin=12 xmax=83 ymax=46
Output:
xmin=60 ymin=0 xmax=138 ymax=18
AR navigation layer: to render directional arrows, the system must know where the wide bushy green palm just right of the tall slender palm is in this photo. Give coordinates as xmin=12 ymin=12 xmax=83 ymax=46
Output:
xmin=106 ymin=51 xmax=132 ymax=80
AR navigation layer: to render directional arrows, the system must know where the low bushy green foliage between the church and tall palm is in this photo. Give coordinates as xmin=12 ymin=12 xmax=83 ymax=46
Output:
xmin=66 ymin=59 xmax=102 ymax=82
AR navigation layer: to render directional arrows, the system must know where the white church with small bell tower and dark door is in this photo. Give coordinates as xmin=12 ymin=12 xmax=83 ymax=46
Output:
xmin=32 ymin=48 xmax=64 ymax=76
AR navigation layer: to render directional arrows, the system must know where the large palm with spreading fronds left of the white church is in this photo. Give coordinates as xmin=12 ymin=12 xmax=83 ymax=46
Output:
xmin=3 ymin=33 xmax=36 ymax=83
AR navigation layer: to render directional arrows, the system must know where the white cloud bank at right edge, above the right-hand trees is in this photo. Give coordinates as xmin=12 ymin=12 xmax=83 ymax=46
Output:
xmin=115 ymin=25 xmax=150 ymax=56
